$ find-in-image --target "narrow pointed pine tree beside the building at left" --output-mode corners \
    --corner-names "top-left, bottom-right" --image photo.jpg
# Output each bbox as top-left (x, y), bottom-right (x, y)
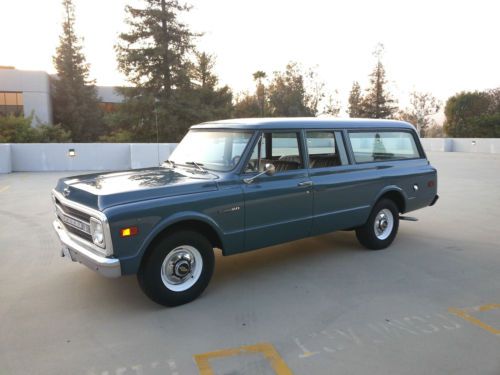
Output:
top-left (52, 0), bottom-right (104, 142)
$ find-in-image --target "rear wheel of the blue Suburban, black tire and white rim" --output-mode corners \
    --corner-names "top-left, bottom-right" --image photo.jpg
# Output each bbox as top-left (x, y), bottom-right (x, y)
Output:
top-left (356, 199), bottom-right (399, 250)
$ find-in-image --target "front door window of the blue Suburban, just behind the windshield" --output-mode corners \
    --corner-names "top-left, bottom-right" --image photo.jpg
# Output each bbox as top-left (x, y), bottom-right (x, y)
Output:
top-left (245, 132), bottom-right (304, 172)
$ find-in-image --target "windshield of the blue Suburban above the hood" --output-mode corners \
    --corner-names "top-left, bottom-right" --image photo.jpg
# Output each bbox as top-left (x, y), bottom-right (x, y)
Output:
top-left (169, 130), bottom-right (252, 172)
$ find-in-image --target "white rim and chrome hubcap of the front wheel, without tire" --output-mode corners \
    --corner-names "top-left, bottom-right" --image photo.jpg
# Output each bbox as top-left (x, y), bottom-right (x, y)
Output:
top-left (161, 245), bottom-right (203, 292)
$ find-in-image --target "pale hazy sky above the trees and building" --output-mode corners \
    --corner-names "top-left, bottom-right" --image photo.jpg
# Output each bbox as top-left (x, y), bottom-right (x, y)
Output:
top-left (0, 0), bottom-right (500, 114)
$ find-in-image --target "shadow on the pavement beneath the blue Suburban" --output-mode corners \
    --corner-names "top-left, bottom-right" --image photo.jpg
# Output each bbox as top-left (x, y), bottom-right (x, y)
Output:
top-left (57, 232), bottom-right (363, 314)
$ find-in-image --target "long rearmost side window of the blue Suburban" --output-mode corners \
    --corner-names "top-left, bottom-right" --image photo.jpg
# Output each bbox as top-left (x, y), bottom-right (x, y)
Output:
top-left (349, 131), bottom-right (420, 163)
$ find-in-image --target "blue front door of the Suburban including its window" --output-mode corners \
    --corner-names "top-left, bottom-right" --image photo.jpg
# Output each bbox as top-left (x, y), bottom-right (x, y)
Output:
top-left (242, 131), bottom-right (313, 250)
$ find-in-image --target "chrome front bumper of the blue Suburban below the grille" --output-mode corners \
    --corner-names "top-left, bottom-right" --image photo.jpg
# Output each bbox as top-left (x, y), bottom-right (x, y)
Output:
top-left (52, 220), bottom-right (122, 277)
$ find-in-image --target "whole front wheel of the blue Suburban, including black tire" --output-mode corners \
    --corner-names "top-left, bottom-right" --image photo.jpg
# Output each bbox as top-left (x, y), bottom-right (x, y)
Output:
top-left (137, 230), bottom-right (214, 306)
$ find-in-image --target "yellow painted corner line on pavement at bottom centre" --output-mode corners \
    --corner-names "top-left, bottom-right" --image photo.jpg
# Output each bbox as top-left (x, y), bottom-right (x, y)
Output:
top-left (193, 343), bottom-right (293, 375)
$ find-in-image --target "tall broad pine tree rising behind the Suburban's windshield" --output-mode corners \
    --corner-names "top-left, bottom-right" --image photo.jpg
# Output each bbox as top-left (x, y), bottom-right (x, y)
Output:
top-left (115, 0), bottom-right (199, 141)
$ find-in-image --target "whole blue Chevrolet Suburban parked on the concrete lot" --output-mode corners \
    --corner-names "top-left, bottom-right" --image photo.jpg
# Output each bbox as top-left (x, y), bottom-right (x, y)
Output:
top-left (52, 118), bottom-right (438, 306)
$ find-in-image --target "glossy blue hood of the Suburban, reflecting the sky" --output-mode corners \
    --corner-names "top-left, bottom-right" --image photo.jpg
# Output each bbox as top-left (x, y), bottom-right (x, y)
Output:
top-left (56, 168), bottom-right (217, 210)
